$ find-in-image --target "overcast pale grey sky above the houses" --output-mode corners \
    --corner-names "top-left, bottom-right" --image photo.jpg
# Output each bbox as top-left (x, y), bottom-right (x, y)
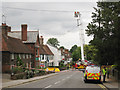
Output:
top-left (2, 0), bottom-right (97, 49)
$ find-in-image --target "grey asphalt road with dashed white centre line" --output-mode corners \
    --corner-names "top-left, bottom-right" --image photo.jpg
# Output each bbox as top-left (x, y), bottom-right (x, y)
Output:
top-left (10, 70), bottom-right (102, 90)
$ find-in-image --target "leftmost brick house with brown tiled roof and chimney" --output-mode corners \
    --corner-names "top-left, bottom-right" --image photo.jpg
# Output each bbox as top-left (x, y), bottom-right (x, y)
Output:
top-left (0, 24), bottom-right (33, 73)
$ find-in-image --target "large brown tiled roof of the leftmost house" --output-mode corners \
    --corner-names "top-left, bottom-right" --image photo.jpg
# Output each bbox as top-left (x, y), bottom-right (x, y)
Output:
top-left (2, 35), bottom-right (32, 53)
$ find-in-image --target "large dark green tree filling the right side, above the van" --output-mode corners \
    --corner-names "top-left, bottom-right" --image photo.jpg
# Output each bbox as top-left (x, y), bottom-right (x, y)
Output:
top-left (86, 2), bottom-right (120, 66)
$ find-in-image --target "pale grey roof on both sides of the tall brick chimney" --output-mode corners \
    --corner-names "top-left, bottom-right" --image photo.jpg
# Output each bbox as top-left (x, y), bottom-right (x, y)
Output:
top-left (8, 31), bottom-right (39, 43)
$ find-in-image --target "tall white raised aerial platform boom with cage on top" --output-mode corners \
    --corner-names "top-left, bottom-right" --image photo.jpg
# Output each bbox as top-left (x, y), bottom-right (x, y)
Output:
top-left (74, 12), bottom-right (84, 62)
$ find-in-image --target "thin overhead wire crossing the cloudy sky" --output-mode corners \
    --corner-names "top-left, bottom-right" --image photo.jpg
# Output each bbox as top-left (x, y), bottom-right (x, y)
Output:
top-left (3, 7), bottom-right (91, 12)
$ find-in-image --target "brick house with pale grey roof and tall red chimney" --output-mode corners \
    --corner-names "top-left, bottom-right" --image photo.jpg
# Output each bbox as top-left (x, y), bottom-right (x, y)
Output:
top-left (8, 24), bottom-right (40, 67)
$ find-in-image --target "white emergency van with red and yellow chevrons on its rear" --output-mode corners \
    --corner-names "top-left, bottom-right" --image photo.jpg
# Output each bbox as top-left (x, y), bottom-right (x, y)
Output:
top-left (84, 65), bottom-right (101, 83)
